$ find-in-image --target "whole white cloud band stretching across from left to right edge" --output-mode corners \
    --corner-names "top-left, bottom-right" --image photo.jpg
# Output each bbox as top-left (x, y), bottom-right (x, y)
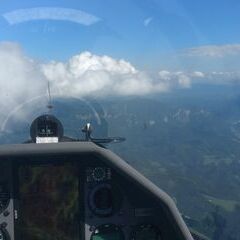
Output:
top-left (0, 42), bottom-right (240, 129)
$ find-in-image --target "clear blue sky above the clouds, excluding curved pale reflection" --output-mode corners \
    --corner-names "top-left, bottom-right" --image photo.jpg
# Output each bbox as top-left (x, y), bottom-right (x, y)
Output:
top-left (0, 0), bottom-right (240, 70)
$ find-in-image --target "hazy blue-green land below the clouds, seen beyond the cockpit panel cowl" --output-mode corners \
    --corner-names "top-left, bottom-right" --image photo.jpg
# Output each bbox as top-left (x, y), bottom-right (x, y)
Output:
top-left (0, 86), bottom-right (240, 240)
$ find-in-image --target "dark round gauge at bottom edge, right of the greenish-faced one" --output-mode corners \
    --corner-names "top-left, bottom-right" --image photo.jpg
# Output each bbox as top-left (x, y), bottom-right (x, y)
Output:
top-left (131, 224), bottom-right (162, 240)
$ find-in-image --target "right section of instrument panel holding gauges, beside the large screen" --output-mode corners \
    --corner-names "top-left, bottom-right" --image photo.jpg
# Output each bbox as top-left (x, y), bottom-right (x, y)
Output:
top-left (84, 165), bottom-right (163, 240)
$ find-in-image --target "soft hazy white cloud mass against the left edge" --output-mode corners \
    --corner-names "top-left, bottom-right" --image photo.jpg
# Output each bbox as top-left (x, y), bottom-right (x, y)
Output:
top-left (0, 42), bottom-right (45, 119)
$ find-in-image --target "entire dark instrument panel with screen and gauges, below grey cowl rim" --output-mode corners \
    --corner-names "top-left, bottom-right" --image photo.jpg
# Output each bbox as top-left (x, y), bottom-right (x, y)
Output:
top-left (0, 153), bottom-right (189, 240)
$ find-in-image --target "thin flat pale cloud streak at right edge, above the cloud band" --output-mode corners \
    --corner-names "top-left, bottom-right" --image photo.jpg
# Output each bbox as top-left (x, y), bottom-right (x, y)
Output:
top-left (182, 44), bottom-right (240, 58)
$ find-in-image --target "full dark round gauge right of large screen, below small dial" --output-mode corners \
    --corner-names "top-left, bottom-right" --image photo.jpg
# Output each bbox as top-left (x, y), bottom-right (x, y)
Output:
top-left (88, 183), bottom-right (122, 217)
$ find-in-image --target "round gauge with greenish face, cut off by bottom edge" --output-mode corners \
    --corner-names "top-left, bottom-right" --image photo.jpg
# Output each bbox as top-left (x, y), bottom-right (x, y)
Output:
top-left (91, 224), bottom-right (124, 240)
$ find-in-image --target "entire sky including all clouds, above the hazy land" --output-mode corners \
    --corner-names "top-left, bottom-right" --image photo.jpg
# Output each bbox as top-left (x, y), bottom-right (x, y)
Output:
top-left (0, 0), bottom-right (240, 125)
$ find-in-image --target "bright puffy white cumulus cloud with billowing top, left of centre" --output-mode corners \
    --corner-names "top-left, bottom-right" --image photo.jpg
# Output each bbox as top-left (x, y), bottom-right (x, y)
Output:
top-left (42, 52), bottom-right (177, 96)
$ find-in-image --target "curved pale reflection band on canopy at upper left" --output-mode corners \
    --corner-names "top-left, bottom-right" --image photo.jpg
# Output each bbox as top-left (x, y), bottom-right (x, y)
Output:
top-left (3, 7), bottom-right (100, 26)
